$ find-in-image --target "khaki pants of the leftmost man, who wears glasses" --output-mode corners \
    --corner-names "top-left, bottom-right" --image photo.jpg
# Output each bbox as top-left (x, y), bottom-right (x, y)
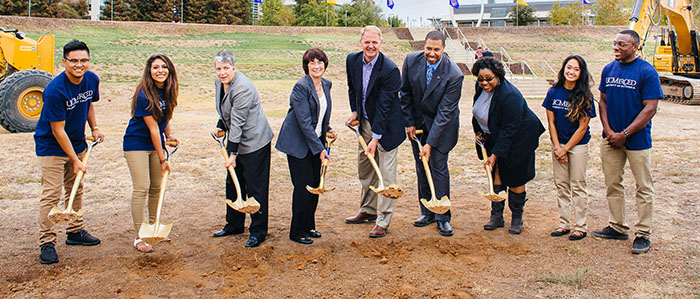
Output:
top-left (39, 152), bottom-right (85, 245)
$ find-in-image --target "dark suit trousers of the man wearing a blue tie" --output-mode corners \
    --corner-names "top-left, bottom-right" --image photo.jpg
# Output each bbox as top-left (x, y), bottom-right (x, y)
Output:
top-left (411, 135), bottom-right (452, 221)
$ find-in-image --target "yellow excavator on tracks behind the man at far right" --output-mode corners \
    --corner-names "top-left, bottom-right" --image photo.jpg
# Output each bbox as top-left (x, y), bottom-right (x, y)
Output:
top-left (629, 0), bottom-right (700, 105)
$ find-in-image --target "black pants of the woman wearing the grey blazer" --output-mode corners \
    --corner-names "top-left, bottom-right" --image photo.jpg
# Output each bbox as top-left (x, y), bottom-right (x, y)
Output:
top-left (224, 143), bottom-right (271, 241)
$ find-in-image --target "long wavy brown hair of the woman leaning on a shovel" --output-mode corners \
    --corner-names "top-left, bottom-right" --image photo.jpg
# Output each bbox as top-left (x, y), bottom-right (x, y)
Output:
top-left (131, 54), bottom-right (179, 122)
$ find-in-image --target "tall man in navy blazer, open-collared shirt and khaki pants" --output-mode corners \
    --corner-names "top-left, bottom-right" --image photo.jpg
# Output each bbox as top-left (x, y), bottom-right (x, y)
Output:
top-left (345, 26), bottom-right (406, 238)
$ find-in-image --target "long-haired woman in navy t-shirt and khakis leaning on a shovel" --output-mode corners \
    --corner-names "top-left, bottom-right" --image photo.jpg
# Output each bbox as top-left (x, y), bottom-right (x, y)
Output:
top-left (123, 54), bottom-right (178, 252)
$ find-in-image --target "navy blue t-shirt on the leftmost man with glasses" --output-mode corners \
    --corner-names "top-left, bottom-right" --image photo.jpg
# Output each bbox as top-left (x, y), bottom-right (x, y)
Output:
top-left (34, 71), bottom-right (100, 156)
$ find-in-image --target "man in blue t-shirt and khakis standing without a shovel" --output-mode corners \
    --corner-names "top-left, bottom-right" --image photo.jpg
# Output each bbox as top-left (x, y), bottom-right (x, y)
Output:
top-left (593, 30), bottom-right (664, 254)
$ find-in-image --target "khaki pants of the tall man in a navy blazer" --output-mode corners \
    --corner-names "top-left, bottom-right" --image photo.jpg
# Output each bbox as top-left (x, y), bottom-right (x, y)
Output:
top-left (357, 118), bottom-right (399, 228)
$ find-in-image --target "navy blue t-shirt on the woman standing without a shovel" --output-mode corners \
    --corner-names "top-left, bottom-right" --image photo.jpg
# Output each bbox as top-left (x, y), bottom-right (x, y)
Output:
top-left (542, 86), bottom-right (596, 145)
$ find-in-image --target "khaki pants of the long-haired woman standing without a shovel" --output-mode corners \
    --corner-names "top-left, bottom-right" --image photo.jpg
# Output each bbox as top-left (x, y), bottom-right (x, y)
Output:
top-left (552, 144), bottom-right (588, 232)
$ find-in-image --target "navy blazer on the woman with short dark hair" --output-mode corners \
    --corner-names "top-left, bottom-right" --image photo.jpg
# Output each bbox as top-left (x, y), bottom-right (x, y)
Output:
top-left (275, 75), bottom-right (333, 159)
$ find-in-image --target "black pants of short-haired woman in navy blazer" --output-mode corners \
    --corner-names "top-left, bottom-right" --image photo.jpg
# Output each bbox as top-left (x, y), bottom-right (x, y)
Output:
top-left (287, 151), bottom-right (321, 239)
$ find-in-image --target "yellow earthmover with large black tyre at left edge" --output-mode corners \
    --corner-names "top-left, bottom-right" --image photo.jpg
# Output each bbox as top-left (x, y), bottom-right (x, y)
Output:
top-left (0, 27), bottom-right (54, 133)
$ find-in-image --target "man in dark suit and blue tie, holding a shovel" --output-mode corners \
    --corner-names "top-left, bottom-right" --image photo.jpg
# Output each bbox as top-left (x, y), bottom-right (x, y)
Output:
top-left (401, 31), bottom-right (464, 236)
